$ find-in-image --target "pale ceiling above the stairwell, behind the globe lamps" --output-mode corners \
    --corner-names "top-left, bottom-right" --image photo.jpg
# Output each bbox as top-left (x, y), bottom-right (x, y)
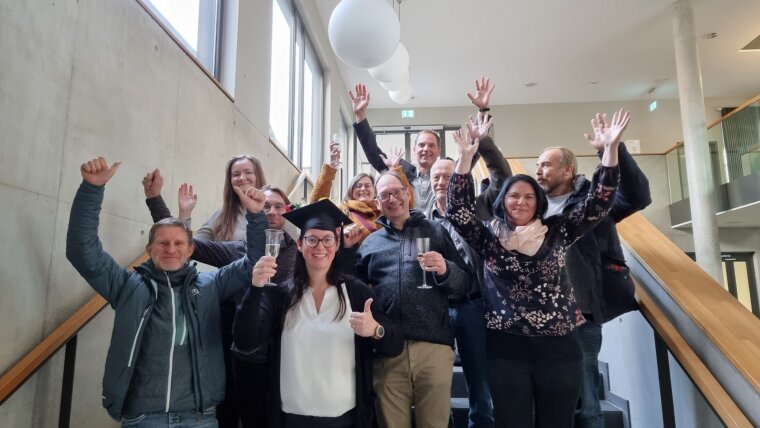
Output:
top-left (316, 0), bottom-right (760, 108)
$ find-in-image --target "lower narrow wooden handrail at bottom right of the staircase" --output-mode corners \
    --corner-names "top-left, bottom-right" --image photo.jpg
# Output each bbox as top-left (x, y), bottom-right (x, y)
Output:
top-left (636, 283), bottom-right (752, 427)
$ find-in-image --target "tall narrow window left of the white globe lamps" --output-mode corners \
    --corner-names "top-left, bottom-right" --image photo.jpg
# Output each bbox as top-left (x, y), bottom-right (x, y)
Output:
top-left (269, 0), bottom-right (323, 178)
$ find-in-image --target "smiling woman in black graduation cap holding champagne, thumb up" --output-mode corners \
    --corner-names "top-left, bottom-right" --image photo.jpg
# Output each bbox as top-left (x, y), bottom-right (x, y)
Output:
top-left (233, 200), bottom-right (404, 428)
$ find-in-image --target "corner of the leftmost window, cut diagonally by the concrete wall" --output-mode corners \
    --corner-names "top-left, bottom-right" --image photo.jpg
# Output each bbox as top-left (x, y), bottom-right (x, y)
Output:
top-left (143, 0), bottom-right (222, 79)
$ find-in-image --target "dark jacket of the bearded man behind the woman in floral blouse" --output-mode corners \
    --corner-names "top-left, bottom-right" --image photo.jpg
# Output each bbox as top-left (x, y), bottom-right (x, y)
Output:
top-left (562, 144), bottom-right (652, 324)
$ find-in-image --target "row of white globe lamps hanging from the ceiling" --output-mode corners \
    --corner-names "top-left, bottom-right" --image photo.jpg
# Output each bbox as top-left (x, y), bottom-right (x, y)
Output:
top-left (327, 0), bottom-right (412, 104)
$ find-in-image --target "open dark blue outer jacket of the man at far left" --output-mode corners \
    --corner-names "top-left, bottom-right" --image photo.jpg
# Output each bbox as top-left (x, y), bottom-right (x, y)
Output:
top-left (66, 182), bottom-right (267, 420)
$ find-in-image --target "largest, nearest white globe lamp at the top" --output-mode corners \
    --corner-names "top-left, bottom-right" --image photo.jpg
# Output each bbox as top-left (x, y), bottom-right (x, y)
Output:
top-left (327, 0), bottom-right (401, 68)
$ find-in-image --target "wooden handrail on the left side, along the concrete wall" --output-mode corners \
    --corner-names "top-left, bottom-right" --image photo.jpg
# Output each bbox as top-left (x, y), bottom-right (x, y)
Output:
top-left (0, 253), bottom-right (148, 404)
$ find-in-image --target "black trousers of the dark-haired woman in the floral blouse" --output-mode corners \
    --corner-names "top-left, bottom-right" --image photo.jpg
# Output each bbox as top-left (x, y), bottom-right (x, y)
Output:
top-left (487, 330), bottom-right (583, 428)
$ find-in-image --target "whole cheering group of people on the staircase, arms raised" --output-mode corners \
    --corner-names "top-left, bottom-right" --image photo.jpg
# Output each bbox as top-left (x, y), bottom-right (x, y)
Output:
top-left (66, 78), bottom-right (651, 428)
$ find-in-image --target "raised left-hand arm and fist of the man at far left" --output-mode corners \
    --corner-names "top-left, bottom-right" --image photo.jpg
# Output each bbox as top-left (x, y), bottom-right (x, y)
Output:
top-left (66, 157), bottom-right (128, 306)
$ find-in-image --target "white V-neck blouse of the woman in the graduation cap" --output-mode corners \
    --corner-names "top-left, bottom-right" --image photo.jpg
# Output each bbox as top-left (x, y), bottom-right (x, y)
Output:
top-left (280, 284), bottom-right (356, 417)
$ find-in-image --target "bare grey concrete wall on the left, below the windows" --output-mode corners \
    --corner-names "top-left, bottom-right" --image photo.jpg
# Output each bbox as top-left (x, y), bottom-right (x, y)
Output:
top-left (0, 0), bottom-right (348, 427)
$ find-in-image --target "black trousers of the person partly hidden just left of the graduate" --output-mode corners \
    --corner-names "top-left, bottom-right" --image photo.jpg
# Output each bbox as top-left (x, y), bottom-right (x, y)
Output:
top-left (232, 358), bottom-right (271, 428)
